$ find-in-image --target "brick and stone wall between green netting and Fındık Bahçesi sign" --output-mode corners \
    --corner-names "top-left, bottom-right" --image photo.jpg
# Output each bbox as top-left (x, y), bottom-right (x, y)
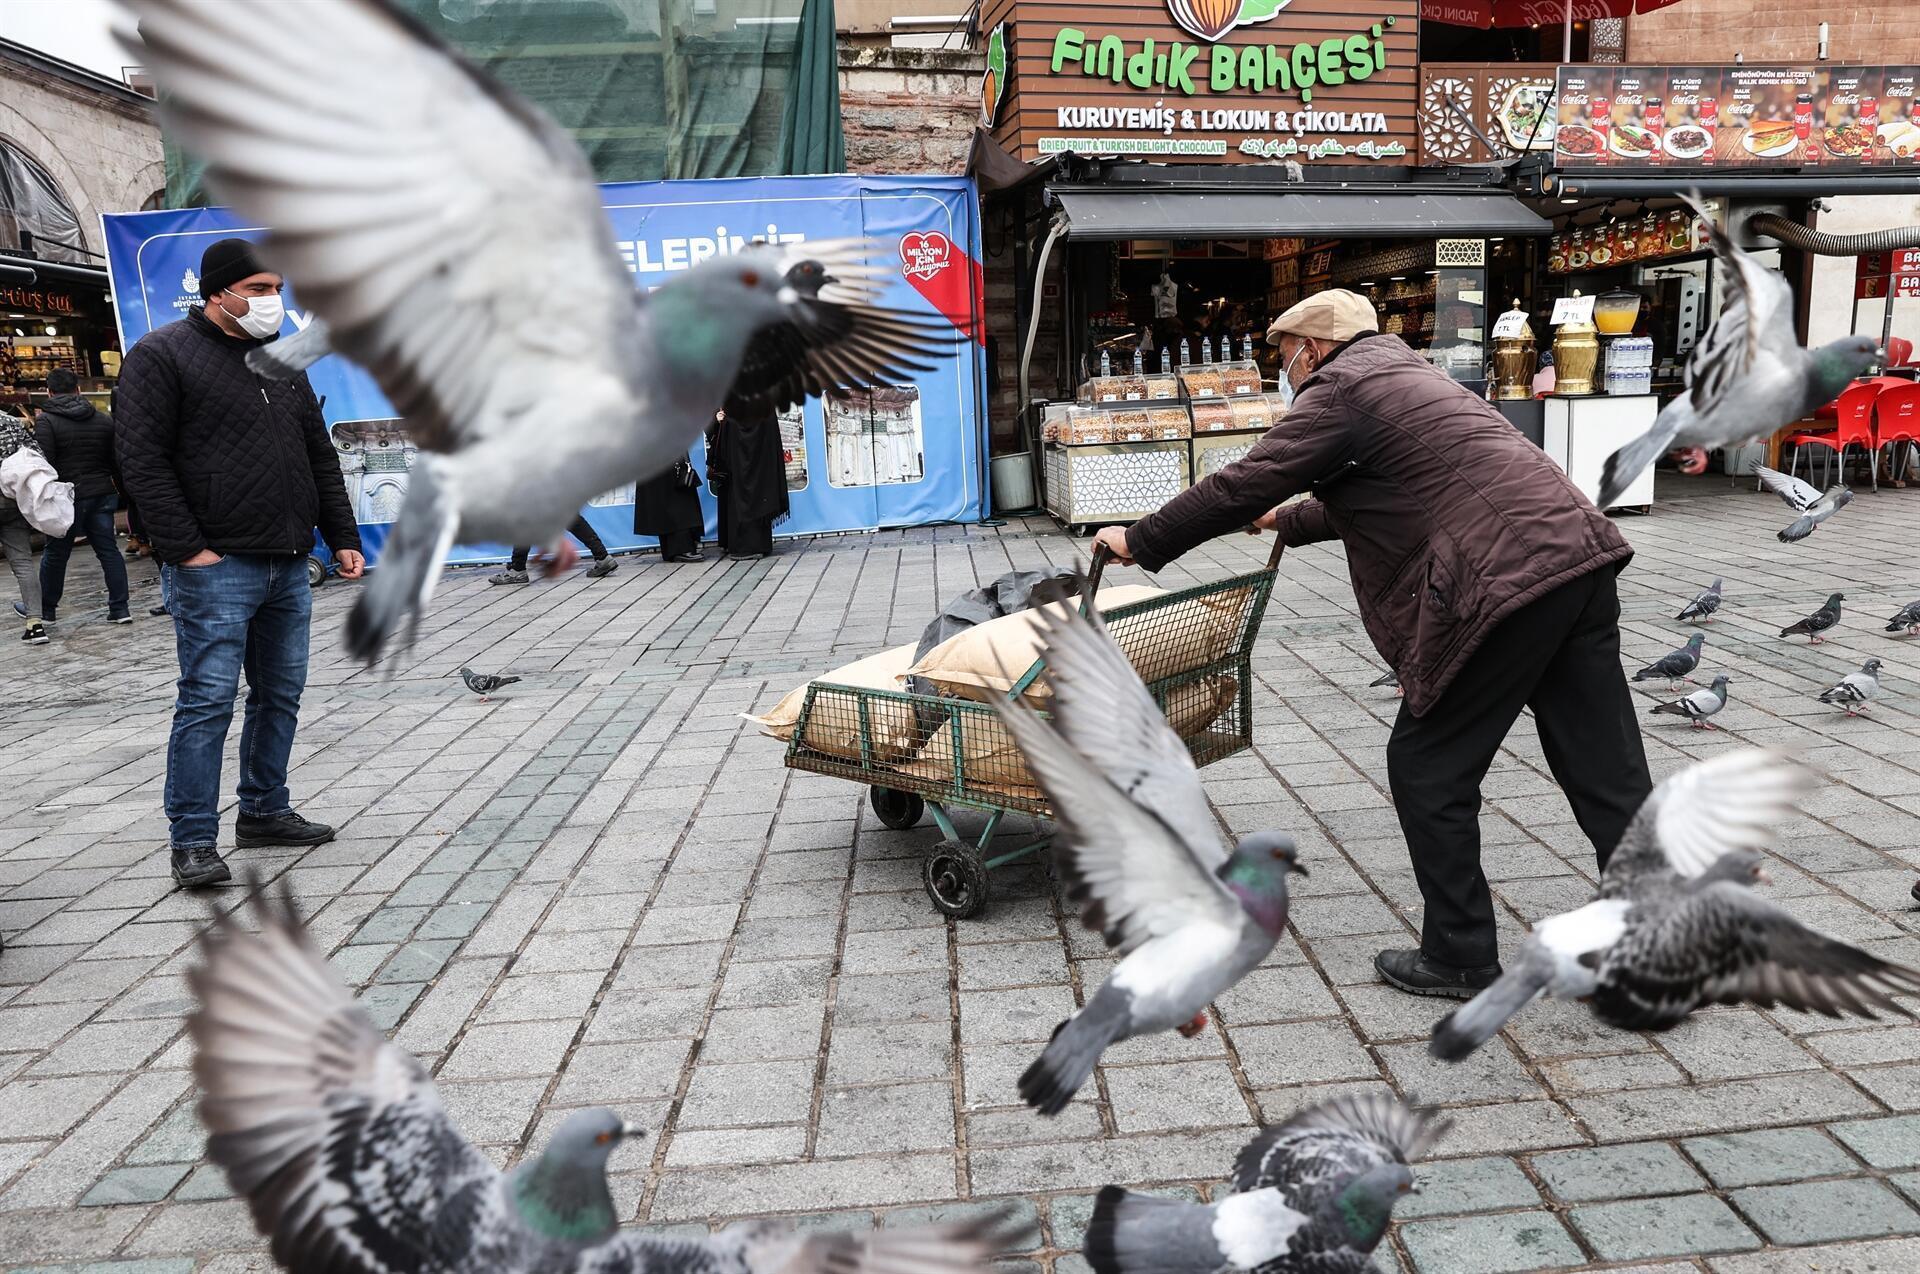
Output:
top-left (839, 44), bottom-right (985, 175)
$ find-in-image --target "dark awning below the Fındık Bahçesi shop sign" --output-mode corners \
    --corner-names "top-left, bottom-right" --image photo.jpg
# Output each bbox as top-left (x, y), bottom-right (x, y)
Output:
top-left (1048, 186), bottom-right (1553, 240)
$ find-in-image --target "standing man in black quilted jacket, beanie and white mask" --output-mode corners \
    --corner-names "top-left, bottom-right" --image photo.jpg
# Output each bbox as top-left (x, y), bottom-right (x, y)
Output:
top-left (115, 238), bottom-right (365, 888)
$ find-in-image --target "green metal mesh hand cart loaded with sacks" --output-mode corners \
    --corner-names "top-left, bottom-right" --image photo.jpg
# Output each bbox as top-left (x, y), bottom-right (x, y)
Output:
top-left (785, 543), bottom-right (1283, 919)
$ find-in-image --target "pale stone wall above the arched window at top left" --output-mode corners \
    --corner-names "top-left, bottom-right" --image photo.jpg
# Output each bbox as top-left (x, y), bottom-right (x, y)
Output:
top-left (0, 50), bottom-right (167, 251)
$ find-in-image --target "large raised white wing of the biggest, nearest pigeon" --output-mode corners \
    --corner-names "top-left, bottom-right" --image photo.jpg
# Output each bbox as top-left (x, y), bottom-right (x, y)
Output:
top-left (127, 0), bottom-right (639, 451)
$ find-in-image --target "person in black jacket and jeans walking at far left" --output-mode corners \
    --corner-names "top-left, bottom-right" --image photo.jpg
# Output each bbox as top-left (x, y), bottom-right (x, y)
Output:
top-left (33, 368), bottom-right (132, 624)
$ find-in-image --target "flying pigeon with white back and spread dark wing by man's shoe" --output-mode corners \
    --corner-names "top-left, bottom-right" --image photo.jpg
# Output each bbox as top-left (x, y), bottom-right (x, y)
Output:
top-left (1430, 748), bottom-right (1920, 1061)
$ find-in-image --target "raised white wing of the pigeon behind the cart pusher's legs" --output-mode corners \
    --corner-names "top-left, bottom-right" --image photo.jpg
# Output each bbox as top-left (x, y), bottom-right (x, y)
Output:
top-left (1601, 748), bottom-right (1811, 892)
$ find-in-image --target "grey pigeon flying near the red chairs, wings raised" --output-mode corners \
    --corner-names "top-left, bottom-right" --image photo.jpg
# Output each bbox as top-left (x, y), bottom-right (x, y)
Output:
top-left (1596, 196), bottom-right (1880, 508)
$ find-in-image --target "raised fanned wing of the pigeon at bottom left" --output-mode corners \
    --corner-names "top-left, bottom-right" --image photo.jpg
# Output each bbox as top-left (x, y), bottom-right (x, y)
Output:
top-left (186, 882), bottom-right (495, 1274)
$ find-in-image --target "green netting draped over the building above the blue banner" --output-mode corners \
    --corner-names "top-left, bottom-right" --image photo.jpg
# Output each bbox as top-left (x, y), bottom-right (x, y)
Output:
top-left (167, 0), bottom-right (817, 207)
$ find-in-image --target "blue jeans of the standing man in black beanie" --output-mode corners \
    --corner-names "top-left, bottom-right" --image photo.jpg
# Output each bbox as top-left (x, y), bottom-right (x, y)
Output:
top-left (163, 553), bottom-right (313, 848)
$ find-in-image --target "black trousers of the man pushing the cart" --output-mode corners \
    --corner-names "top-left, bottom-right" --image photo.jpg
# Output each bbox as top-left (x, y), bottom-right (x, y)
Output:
top-left (1386, 568), bottom-right (1653, 967)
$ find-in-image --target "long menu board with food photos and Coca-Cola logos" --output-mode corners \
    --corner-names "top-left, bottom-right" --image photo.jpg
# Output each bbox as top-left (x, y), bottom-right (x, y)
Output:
top-left (1553, 65), bottom-right (1920, 169)
